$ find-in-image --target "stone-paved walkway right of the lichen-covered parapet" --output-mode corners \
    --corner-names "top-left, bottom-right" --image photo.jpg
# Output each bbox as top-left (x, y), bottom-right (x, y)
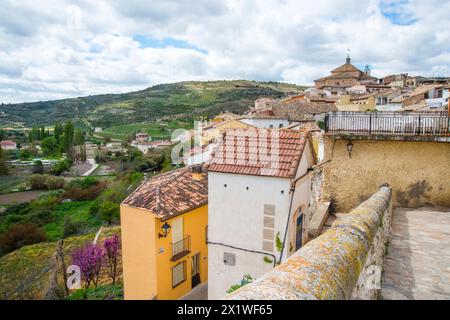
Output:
top-left (381, 208), bottom-right (450, 300)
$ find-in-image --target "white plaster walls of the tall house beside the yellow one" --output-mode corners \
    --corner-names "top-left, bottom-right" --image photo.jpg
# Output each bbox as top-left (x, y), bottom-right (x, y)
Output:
top-left (208, 144), bottom-right (312, 299)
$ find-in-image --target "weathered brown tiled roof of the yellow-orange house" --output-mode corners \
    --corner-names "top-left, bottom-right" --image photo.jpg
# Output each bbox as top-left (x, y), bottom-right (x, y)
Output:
top-left (122, 166), bottom-right (208, 219)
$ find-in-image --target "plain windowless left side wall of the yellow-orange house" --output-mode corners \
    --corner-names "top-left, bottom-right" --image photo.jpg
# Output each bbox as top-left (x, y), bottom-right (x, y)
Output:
top-left (120, 205), bottom-right (157, 300)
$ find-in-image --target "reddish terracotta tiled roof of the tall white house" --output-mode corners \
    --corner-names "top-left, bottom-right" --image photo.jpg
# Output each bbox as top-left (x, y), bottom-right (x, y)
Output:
top-left (208, 129), bottom-right (309, 178)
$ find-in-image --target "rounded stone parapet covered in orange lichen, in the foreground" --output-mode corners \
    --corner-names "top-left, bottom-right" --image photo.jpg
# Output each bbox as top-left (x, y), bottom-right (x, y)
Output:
top-left (226, 186), bottom-right (392, 300)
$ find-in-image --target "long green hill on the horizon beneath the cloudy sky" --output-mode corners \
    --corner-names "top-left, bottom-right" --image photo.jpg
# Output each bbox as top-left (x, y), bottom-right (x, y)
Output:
top-left (0, 80), bottom-right (305, 127)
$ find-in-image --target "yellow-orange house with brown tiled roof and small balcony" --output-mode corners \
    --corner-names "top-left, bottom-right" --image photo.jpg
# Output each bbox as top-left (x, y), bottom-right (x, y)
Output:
top-left (120, 166), bottom-right (208, 300)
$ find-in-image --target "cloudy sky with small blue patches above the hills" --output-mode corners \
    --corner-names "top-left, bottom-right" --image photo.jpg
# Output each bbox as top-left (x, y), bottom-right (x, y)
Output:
top-left (0, 0), bottom-right (450, 102)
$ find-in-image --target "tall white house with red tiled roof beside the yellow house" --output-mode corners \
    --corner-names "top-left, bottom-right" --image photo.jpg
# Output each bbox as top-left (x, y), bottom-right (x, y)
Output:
top-left (208, 129), bottom-right (316, 299)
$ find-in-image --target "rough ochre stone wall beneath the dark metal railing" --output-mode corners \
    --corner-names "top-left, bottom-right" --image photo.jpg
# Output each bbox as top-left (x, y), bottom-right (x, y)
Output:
top-left (322, 136), bottom-right (450, 212)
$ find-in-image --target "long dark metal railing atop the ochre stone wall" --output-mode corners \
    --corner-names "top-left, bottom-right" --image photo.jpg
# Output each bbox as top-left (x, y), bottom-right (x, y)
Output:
top-left (325, 111), bottom-right (450, 136)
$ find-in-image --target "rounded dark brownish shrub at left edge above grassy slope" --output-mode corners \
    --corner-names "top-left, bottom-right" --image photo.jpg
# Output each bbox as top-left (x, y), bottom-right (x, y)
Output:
top-left (0, 224), bottom-right (46, 254)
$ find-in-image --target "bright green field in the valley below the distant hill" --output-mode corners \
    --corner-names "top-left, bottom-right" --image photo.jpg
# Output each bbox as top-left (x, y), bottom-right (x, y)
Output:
top-left (96, 120), bottom-right (194, 140)
